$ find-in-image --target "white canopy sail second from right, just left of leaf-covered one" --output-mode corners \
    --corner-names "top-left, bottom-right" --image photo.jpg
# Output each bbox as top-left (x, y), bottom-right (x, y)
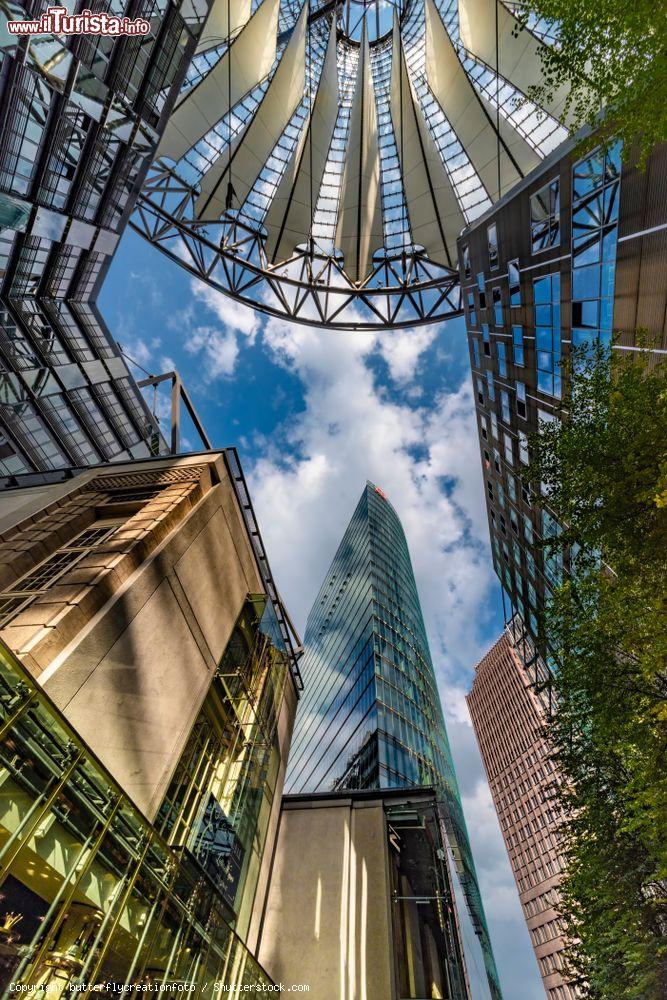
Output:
top-left (426, 0), bottom-right (540, 200)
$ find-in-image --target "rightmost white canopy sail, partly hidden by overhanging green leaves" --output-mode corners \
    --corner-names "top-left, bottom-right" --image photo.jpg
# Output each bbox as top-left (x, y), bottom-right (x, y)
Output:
top-left (459, 0), bottom-right (568, 125)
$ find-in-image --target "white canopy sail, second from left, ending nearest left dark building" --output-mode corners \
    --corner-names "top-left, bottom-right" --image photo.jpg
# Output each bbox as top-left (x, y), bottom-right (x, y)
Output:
top-left (157, 0), bottom-right (280, 160)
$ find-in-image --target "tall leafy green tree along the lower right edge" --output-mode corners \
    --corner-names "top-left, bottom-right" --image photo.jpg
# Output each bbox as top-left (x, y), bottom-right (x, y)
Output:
top-left (529, 342), bottom-right (667, 1000)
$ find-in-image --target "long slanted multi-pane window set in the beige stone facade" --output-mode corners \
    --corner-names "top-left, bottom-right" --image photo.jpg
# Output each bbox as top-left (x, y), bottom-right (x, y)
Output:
top-left (0, 521), bottom-right (123, 628)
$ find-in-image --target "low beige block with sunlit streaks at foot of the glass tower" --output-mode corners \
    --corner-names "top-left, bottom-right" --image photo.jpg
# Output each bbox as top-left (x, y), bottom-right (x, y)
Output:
top-left (259, 788), bottom-right (469, 1000)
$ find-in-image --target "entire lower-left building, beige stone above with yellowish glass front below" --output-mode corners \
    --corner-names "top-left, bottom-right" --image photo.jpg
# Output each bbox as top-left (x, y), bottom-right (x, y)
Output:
top-left (0, 450), bottom-right (300, 1000)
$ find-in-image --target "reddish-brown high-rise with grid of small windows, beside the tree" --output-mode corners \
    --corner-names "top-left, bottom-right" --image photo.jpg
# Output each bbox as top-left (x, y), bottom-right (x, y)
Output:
top-left (467, 631), bottom-right (580, 1000)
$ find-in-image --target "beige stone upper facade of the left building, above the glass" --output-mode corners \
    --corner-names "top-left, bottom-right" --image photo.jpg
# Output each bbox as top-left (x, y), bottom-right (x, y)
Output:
top-left (0, 453), bottom-right (294, 819)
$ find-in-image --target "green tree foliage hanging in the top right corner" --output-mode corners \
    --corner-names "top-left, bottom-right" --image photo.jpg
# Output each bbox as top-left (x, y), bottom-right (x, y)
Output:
top-left (517, 0), bottom-right (667, 163)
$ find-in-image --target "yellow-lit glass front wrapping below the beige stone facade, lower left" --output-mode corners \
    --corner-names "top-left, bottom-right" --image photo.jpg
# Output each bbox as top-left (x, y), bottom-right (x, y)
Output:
top-left (0, 598), bottom-right (288, 997)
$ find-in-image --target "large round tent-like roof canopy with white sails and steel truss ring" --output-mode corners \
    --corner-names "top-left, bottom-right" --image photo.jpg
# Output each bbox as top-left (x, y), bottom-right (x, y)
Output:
top-left (133, 0), bottom-right (567, 328)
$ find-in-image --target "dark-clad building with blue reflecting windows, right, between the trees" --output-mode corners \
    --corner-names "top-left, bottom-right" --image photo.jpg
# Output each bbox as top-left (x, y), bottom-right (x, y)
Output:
top-left (459, 133), bottom-right (667, 664)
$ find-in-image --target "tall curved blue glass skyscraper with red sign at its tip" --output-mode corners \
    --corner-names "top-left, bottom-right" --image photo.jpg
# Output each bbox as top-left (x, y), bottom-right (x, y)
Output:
top-left (286, 483), bottom-right (500, 997)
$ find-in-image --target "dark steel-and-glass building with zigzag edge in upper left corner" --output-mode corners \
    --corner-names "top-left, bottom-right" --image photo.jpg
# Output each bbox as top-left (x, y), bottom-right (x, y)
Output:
top-left (0, 0), bottom-right (213, 483)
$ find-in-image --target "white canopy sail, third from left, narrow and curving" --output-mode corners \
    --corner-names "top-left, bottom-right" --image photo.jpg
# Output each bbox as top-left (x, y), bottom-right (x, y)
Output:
top-left (195, 3), bottom-right (308, 219)
